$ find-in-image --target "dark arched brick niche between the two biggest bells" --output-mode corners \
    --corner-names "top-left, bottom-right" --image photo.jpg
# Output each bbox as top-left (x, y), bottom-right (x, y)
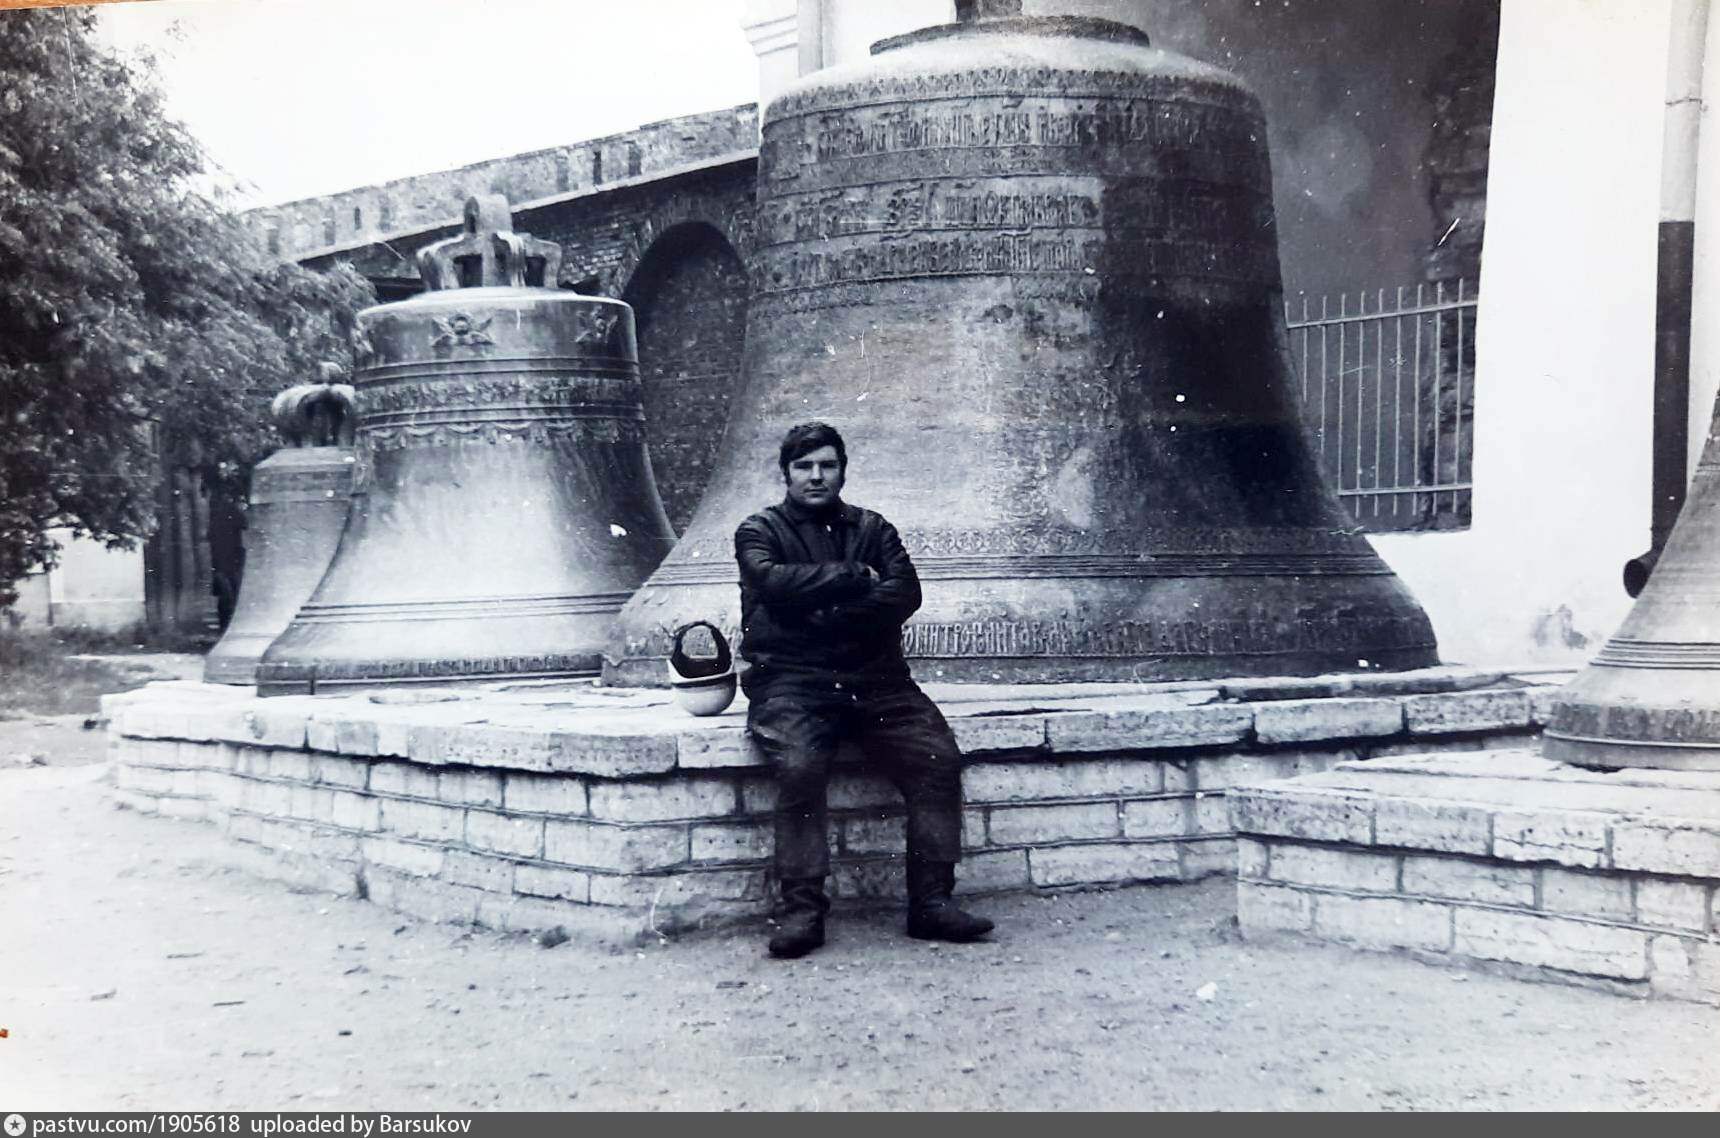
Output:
top-left (621, 220), bottom-right (746, 533)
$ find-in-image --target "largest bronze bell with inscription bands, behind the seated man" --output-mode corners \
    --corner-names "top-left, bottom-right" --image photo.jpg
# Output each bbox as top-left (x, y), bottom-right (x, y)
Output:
top-left (605, 17), bottom-right (1436, 682)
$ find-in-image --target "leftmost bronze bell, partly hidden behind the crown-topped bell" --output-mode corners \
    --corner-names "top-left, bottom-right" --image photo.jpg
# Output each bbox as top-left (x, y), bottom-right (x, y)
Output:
top-left (203, 374), bottom-right (356, 684)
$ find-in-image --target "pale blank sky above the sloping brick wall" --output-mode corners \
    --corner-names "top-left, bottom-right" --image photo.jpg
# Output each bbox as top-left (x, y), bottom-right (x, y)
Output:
top-left (100, 0), bottom-right (759, 206)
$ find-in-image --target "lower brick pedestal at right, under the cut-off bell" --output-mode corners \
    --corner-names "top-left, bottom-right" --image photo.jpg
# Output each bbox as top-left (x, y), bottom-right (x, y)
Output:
top-left (1230, 749), bottom-right (1720, 1002)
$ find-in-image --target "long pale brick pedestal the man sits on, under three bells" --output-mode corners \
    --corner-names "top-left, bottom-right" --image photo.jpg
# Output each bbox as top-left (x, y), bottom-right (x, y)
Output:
top-left (105, 669), bottom-right (1567, 935)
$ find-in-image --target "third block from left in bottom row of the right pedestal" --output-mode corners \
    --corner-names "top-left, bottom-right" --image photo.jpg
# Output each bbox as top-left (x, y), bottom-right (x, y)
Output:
top-left (1455, 908), bottom-right (1648, 980)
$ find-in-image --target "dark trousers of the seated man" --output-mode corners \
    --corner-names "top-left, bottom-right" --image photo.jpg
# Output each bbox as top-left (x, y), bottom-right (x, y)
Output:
top-left (746, 679), bottom-right (961, 882)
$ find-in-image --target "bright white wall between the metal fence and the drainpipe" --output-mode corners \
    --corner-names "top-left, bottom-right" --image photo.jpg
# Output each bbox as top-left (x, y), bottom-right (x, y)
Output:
top-left (1374, 0), bottom-right (1664, 664)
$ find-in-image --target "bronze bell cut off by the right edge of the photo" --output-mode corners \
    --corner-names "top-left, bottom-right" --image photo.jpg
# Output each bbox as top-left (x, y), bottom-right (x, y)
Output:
top-left (1541, 388), bottom-right (1720, 770)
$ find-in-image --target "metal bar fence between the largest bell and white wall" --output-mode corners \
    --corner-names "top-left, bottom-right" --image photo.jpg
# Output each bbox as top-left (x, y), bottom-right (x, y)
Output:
top-left (1285, 280), bottom-right (1477, 531)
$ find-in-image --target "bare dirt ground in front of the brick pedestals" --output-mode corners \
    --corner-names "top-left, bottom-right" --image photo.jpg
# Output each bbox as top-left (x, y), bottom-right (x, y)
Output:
top-left (0, 717), bottom-right (1720, 1110)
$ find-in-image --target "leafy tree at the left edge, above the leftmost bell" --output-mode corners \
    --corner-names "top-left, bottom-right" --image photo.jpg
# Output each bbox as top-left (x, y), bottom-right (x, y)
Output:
top-left (0, 9), bottom-right (375, 607)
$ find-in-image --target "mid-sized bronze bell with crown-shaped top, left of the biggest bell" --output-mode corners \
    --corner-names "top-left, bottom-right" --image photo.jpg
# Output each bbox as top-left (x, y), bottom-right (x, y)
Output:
top-left (258, 196), bottom-right (674, 694)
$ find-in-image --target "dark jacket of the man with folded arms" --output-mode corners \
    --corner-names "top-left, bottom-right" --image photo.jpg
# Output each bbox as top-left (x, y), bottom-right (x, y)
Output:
top-left (734, 500), bottom-right (920, 696)
